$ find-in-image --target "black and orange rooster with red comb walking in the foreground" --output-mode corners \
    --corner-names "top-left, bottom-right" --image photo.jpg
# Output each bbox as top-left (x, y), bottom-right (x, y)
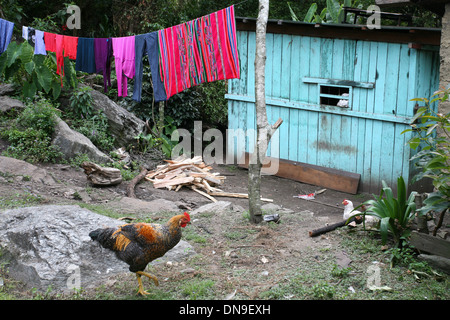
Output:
top-left (89, 212), bottom-right (191, 295)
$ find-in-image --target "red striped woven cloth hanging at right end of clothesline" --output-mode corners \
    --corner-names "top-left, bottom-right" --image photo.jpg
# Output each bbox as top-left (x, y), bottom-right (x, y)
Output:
top-left (159, 6), bottom-right (240, 98)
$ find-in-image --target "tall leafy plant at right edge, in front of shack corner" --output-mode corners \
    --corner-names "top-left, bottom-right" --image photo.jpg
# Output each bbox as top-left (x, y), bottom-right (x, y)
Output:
top-left (402, 89), bottom-right (450, 218)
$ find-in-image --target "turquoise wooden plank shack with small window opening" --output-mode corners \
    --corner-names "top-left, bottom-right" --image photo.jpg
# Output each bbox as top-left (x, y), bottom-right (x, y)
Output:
top-left (226, 18), bottom-right (440, 193)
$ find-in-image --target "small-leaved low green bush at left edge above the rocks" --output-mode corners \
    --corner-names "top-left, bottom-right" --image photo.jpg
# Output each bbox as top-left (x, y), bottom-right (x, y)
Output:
top-left (0, 97), bottom-right (61, 163)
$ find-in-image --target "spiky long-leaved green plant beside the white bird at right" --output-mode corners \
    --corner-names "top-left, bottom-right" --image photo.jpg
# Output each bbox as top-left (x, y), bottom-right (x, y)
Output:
top-left (355, 177), bottom-right (416, 247)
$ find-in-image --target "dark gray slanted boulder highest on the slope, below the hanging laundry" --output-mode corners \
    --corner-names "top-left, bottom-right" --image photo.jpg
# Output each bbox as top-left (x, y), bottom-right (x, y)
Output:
top-left (91, 90), bottom-right (145, 147)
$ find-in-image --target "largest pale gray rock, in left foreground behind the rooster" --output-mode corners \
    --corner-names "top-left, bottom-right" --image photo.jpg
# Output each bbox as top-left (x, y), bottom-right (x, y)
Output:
top-left (0, 205), bottom-right (194, 291)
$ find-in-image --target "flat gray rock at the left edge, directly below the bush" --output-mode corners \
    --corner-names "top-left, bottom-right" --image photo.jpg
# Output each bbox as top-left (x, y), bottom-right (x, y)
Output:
top-left (0, 156), bottom-right (56, 185)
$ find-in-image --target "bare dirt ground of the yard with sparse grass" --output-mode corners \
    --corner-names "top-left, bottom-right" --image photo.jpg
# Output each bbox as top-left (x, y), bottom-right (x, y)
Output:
top-left (0, 148), bottom-right (448, 299)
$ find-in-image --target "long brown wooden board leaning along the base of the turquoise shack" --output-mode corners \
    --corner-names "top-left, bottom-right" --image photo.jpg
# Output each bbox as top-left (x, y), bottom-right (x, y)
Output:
top-left (239, 152), bottom-right (361, 194)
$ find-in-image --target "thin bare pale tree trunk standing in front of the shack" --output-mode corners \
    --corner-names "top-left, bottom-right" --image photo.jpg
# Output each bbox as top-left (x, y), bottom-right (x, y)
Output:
top-left (248, 0), bottom-right (282, 223)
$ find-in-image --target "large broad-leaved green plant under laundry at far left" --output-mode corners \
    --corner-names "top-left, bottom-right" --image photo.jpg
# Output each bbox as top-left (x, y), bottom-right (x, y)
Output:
top-left (0, 41), bottom-right (77, 99)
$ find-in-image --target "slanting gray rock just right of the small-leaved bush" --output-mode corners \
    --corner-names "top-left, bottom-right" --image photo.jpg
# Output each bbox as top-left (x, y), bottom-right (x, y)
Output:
top-left (52, 118), bottom-right (112, 163)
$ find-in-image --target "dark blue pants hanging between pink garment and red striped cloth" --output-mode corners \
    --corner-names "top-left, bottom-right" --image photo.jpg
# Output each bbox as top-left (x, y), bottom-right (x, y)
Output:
top-left (133, 31), bottom-right (167, 102)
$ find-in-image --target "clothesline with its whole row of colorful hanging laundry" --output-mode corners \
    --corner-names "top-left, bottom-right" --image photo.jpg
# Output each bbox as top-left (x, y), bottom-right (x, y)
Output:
top-left (0, 5), bottom-right (241, 102)
